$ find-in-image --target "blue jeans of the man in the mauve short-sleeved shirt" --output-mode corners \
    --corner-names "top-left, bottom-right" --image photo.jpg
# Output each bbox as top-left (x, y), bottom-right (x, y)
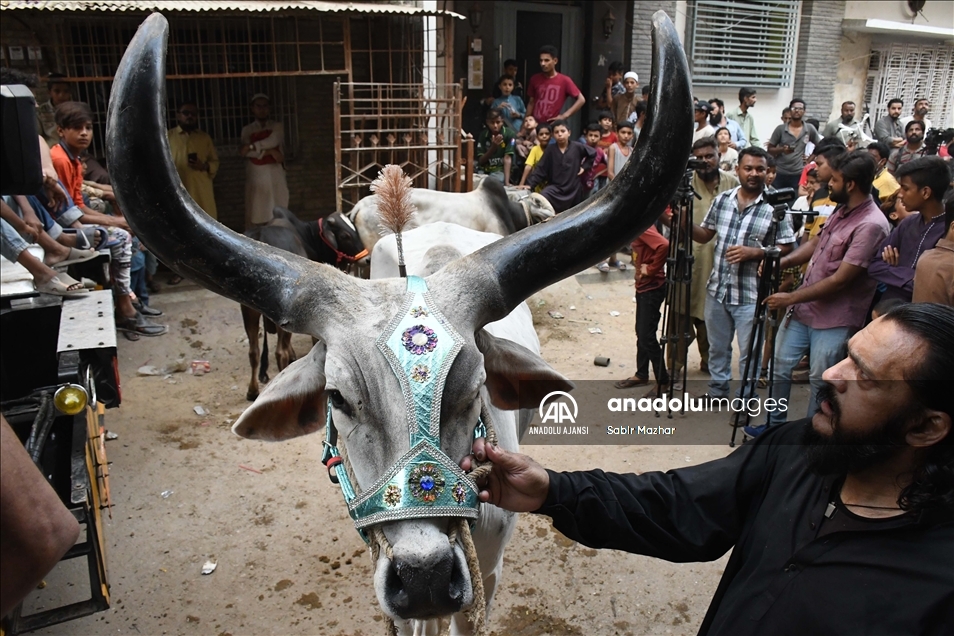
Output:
top-left (769, 318), bottom-right (856, 426)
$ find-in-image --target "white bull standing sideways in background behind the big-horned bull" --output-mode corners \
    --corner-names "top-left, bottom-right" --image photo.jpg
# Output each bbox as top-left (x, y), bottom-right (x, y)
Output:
top-left (349, 179), bottom-right (554, 254)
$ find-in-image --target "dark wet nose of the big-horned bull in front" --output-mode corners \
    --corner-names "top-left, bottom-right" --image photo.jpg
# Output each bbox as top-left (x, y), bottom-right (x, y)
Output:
top-left (385, 545), bottom-right (468, 619)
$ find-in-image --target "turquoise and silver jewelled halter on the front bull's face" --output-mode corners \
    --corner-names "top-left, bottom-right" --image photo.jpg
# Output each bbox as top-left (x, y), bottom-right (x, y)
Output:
top-left (321, 276), bottom-right (487, 543)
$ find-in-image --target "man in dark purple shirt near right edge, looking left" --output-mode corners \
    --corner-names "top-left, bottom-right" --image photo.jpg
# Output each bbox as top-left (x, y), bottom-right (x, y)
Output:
top-left (868, 157), bottom-right (951, 302)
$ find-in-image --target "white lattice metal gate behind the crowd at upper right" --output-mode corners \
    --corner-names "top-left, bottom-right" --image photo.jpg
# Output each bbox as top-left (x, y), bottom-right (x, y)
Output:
top-left (865, 44), bottom-right (954, 128)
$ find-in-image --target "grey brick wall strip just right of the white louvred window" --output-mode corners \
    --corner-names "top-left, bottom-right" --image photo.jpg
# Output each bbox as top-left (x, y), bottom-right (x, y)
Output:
top-left (793, 0), bottom-right (845, 126)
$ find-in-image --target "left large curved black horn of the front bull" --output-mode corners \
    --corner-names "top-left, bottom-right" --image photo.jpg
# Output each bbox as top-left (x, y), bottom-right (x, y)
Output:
top-left (106, 13), bottom-right (336, 331)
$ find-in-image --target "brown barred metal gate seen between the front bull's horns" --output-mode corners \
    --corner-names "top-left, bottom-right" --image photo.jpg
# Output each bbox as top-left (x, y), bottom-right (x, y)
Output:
top-left (334, 82), bottom-right (472, 212)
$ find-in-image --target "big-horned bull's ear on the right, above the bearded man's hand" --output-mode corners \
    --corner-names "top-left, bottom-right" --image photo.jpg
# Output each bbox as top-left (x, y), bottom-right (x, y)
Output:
top-left (474, 329), bottom-right (573, 411)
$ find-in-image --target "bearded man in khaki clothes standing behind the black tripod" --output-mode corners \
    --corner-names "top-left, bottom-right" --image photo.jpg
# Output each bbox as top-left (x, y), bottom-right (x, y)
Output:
top-left (669, 137), bottom-right (739, 376)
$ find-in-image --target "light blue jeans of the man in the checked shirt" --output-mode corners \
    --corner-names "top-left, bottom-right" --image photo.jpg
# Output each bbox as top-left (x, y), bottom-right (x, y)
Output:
top-left (705, 294), bottom-right (758, 397)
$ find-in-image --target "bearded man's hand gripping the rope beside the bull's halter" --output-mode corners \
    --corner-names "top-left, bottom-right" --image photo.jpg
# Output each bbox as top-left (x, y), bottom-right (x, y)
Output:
top-left (460, 439), bottom-right (550, 512)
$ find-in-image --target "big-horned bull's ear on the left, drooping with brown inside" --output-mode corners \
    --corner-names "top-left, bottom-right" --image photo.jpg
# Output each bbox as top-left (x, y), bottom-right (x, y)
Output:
top-left (232, 342), bottom-right (327, 442)
